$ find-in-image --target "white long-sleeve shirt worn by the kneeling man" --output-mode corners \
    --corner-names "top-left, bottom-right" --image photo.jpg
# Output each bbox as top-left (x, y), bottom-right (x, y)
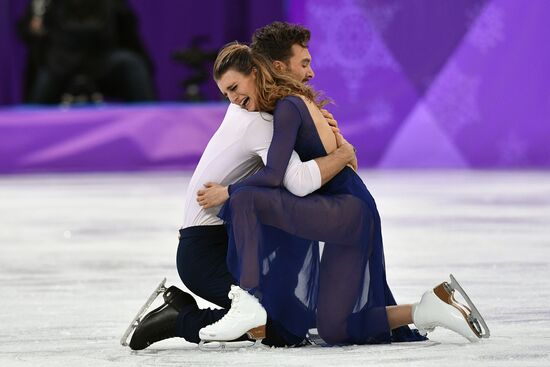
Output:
top-left (182, 104), bottom-right (321, 228)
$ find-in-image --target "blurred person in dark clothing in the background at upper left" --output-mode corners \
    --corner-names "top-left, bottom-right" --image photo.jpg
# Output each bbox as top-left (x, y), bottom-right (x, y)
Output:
top-left (19, 0), bottom-right (155, 104)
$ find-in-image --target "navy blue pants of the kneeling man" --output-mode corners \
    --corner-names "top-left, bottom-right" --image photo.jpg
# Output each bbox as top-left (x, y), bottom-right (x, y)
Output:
top-left (176, 225), bottom-right (302, 346)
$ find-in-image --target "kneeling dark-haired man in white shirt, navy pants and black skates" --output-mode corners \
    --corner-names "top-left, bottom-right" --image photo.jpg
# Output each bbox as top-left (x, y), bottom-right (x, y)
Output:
top-left (125, 22), bottom-right (355, 350)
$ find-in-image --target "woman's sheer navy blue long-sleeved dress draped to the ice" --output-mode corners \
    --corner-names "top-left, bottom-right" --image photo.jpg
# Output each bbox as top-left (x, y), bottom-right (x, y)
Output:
top-left (219, 96), bottom-right (425, 345)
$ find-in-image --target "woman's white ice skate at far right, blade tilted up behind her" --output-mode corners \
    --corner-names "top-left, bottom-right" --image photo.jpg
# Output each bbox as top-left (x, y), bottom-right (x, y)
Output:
top-left (413, 274), bottom-right (490, 342)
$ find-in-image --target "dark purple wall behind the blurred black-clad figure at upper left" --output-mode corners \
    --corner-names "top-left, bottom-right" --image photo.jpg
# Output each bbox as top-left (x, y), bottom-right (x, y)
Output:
top-left (0, 0), bottom-right (285, 105)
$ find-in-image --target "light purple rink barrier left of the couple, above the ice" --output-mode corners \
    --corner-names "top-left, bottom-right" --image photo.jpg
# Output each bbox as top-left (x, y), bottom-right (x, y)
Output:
top-left (0, 104), bottom-right (227, 173)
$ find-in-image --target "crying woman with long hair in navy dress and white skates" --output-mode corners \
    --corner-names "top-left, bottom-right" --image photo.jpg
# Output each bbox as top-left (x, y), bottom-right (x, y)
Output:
top-left (197, 43), bottom-right (490, 345)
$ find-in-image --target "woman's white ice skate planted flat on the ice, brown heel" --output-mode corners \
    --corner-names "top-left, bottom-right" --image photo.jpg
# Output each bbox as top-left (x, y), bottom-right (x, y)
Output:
top-left (199, 285), bottom-right (267, 350)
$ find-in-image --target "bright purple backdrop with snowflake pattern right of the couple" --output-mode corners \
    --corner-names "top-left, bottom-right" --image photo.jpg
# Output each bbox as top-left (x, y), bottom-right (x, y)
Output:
top-left (289, 0), bottom-right (550, 167)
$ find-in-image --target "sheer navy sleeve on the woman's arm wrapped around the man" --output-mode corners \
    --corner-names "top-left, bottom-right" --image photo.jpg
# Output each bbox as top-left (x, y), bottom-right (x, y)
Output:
top-left (228, 98), bottom-right (302, 195)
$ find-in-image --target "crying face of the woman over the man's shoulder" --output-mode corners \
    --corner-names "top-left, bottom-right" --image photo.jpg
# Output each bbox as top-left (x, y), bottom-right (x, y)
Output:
top-left (217, 69), bottom-right (258, 111)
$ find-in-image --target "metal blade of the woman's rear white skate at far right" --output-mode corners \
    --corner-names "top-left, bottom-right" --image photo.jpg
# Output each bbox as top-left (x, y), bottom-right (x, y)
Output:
top-left (439, 274), bottom-right (491, 338)
